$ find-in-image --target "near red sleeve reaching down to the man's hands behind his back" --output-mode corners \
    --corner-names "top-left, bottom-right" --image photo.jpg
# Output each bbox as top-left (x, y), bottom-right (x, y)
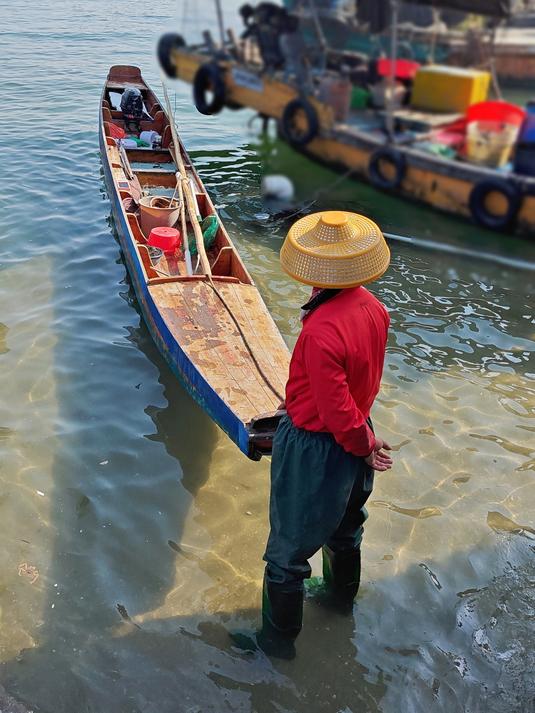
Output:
top-left (303, 335), bottom-right (375, 456)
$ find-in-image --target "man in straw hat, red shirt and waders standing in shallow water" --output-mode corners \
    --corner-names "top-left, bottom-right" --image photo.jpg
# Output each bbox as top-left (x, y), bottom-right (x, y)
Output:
top-left (259, 211), bottom-right (392, 650)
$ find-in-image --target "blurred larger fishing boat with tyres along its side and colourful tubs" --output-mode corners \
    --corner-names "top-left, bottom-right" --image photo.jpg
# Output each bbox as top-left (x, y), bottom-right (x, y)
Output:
top-left (158, 0), bottom-right (535, 236)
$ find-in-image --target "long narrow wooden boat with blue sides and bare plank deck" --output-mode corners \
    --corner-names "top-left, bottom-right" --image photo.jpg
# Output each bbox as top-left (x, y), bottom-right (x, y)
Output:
top-left (100, 66), bottom-right (289, 459)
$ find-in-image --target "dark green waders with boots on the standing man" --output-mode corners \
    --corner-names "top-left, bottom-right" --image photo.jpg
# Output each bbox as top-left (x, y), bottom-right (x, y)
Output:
top-left (262, 416), bottom-right (373, 640)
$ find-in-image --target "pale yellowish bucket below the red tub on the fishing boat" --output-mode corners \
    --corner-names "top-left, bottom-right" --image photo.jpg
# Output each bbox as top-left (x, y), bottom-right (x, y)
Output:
top-left (466, 121), bottom-right (519, 168)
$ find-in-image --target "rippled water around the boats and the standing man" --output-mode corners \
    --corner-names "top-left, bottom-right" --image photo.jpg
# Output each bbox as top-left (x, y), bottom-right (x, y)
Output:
top-left (0, 0), bottom-right (535, 713)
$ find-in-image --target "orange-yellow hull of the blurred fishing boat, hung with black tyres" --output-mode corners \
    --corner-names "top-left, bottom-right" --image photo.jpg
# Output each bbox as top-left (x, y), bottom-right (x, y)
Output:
top-left (159, 33), bottom-right (535, 237)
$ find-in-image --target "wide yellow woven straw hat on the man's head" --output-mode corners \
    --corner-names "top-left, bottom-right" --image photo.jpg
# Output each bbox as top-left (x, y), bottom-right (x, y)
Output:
top-left (280, 210), bottom-right (390, 289)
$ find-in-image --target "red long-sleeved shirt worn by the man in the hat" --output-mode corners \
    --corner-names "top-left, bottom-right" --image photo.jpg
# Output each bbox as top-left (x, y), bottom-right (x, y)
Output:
top-left (286, 287), bottom-right (390, 456)
